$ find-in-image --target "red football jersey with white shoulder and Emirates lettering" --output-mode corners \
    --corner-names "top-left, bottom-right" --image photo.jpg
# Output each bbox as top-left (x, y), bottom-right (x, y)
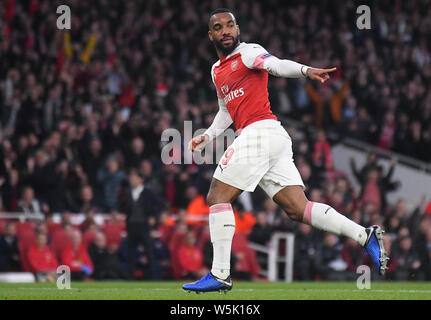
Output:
top-left (211, 42), bottom-right (277, 130)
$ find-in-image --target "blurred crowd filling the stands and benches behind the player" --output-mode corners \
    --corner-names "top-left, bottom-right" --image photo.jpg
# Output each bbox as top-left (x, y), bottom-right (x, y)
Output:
top-left (0, 0), bottom-right (431, 280)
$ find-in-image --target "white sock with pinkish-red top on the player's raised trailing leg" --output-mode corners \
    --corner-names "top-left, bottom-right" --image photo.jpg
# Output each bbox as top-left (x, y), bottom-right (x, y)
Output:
top-left (302, 201), bottom-right (367, 246)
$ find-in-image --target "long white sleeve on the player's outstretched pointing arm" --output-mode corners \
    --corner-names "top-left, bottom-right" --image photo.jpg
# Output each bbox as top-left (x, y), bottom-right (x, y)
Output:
top-left (242, 44), bottom-right (309, 78)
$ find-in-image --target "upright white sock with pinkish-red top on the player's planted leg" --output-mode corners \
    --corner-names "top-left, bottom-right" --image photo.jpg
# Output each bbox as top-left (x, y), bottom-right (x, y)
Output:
top-left (209, 203), bottom-right (235, 280)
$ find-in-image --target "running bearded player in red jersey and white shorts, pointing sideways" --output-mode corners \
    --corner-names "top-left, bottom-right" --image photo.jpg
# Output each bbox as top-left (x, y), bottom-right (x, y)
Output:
top-left (183, 9), bottom-right (389, 293)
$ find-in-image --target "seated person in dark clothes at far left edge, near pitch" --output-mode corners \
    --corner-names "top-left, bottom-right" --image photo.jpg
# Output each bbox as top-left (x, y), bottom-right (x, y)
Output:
top-left (0, 222), bottom-right (21, 272)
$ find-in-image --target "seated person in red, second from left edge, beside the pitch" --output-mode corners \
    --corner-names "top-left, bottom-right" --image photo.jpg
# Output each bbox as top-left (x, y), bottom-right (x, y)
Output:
top-left (27, 232), bottom-right (58, 283)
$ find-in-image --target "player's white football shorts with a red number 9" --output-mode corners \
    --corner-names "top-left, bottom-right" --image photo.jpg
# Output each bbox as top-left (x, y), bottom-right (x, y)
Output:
top-left (214, 119), bottom-right (304, 199)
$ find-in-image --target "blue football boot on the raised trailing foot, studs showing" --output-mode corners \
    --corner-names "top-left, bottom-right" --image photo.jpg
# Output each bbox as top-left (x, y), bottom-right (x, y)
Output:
top-left (364, 226), bottom-right (389, 276)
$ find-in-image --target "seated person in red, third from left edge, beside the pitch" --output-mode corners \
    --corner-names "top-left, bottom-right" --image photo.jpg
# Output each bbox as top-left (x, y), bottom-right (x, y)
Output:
top-left (61, 229), bottom-right (94, 280)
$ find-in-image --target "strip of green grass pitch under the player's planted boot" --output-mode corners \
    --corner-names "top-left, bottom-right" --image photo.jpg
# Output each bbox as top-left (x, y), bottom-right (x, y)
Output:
top-left (0, 281), bottom-right (431, 300)
